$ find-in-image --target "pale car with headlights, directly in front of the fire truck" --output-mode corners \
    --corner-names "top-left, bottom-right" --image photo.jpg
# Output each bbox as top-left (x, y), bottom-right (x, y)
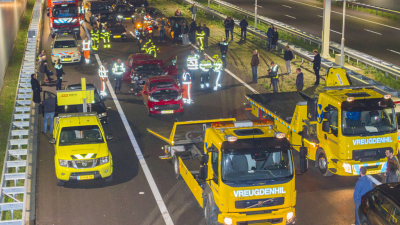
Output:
top-left (51, 35), bottom-right (81, 63)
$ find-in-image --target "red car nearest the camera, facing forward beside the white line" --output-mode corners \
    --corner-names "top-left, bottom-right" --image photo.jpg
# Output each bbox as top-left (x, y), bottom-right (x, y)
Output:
top-left (142, 75), bottom-right (183, 115)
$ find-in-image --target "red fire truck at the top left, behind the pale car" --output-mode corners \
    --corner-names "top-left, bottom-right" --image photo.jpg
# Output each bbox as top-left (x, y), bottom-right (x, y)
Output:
top-left (47, 0), bottom-right (83, 38)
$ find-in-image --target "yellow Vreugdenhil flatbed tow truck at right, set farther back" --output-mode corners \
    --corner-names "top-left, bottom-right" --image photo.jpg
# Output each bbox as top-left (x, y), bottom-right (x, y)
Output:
top-left (246, 68), bottom-right (398, 176)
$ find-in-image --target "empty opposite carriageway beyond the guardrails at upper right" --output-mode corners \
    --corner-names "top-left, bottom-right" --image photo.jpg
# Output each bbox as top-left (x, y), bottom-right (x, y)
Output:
top-left (226, 0), bottom-right (400, 66)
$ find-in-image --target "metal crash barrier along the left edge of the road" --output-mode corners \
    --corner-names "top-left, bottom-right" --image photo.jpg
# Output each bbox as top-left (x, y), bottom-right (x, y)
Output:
top-left (0, 0), bottom-right (42, 225)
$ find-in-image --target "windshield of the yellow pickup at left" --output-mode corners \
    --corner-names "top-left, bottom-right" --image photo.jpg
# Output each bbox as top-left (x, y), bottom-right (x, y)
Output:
top-left (58, 125), bottom-right (104, 146)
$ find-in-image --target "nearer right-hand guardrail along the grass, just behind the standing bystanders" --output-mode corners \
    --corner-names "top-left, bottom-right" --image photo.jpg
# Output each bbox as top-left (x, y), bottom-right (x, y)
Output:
top-left (183, 0), bottom-right (400, 97)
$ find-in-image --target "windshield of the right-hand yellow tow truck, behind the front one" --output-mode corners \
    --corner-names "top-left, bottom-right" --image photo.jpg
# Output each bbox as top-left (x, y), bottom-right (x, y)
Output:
top-left (342, 108), bottom-right (397, 136)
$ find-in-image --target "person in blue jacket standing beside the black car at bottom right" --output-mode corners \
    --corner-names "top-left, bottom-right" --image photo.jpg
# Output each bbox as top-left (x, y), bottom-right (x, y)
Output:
top-left (353, 166), bottom-right (373, 225)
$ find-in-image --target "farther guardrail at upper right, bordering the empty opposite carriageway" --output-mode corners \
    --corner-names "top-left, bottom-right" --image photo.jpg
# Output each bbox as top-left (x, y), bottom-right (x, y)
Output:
top-left (205, 0), bottom-right (400, 80)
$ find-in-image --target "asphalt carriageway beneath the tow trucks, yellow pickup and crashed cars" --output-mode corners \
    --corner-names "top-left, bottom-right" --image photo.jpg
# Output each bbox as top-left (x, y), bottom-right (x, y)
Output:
top-left (36, 3), bottom-right (378, 225)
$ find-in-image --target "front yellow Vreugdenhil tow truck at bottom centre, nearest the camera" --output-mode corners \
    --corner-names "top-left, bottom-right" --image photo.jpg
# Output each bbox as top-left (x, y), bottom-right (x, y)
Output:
top-left (148, 118), bottom-right (306, 225)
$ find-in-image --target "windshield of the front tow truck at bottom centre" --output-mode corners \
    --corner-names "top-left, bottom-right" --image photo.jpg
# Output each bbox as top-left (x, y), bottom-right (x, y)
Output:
top-left (221, 150), bottom-right (293, 182)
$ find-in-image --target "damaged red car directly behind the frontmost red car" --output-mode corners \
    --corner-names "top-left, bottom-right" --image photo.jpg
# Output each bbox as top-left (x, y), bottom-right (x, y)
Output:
top-left (122, 53), bottom-right (178, 83)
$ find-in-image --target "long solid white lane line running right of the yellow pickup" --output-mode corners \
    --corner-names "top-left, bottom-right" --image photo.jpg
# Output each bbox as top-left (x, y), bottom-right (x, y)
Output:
top-left (95, 54), bottom-right (174, 225)
